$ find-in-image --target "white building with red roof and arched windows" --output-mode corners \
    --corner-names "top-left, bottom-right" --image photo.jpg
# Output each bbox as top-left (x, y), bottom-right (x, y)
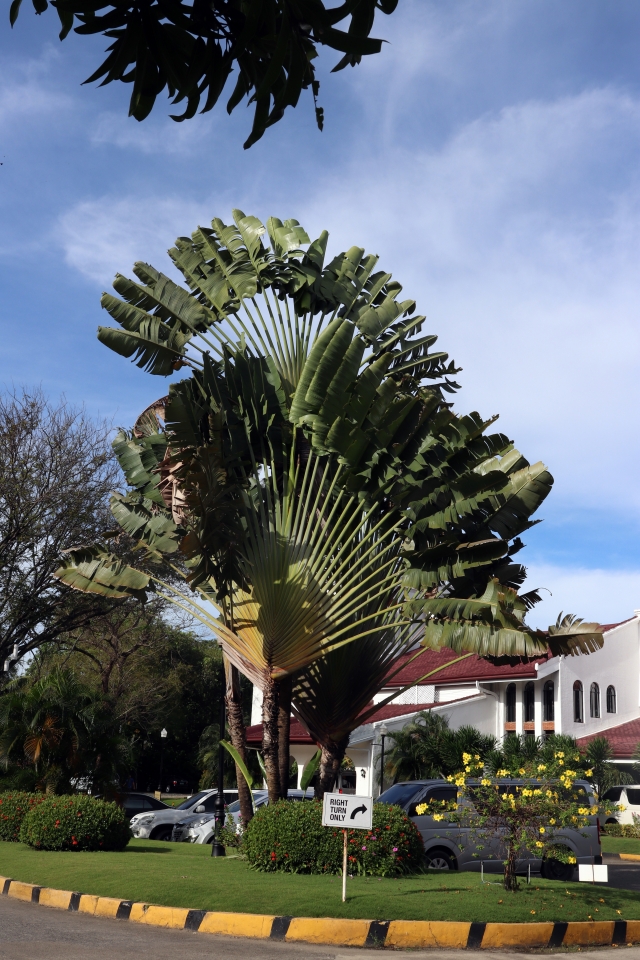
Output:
top-left (247, 610), bottom-right (640, 795)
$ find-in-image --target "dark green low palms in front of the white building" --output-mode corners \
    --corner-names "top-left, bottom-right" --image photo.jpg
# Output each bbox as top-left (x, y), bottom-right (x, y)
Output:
top-left (385, 711), bottom-right (495, 783)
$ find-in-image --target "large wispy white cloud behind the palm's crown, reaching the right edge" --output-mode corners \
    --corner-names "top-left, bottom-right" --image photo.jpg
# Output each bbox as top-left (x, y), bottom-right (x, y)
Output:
top-left (61, 88), bottom-right (640, 513)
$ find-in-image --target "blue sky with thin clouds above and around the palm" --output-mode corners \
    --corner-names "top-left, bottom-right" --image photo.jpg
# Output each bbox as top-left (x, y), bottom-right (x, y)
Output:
top-left (0, 0), bottom-right (640, 625)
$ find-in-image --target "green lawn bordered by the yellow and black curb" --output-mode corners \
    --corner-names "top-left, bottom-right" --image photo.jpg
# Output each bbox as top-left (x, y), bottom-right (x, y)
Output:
top-left (0, 840), bottom-right (640, 922)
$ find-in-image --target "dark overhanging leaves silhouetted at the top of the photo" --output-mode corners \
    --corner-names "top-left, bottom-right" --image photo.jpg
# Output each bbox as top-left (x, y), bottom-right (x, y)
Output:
top-left (10, 0), bottom-right (398, 148)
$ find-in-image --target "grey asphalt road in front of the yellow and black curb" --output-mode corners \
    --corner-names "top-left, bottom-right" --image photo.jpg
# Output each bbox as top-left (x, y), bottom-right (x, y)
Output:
top-left (0, 897), bottom-right (640, 960)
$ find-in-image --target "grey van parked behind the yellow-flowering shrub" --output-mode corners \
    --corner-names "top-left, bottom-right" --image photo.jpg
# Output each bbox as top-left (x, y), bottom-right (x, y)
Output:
top-left (376, 780), bottom-right (602, 883)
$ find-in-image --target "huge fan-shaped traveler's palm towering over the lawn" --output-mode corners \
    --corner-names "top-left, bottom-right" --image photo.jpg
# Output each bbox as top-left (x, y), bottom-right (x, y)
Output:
top-left (59, 211), bottom-right (602, 796)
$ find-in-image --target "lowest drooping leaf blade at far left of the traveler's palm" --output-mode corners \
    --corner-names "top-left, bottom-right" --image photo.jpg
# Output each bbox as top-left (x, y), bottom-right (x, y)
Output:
top-left (54, 544), bottom-right (153, 600)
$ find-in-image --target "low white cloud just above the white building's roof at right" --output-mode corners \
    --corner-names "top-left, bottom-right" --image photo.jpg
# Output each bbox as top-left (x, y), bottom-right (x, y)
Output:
top-left (527, 564), bottom-right (640, 629)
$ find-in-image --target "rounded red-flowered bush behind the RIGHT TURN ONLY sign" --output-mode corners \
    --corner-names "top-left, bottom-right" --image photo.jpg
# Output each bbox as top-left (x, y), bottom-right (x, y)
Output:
top-left (242, 800), bottom-right (424, 877)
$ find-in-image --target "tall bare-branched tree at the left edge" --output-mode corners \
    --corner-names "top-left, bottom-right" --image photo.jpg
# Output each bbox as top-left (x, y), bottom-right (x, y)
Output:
top-left (0, 390), bottom-right (118, 676)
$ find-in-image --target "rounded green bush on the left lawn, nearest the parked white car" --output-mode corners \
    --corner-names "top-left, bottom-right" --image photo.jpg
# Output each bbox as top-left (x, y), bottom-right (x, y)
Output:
top-left (20, 797), bottom-right (131, 850)
